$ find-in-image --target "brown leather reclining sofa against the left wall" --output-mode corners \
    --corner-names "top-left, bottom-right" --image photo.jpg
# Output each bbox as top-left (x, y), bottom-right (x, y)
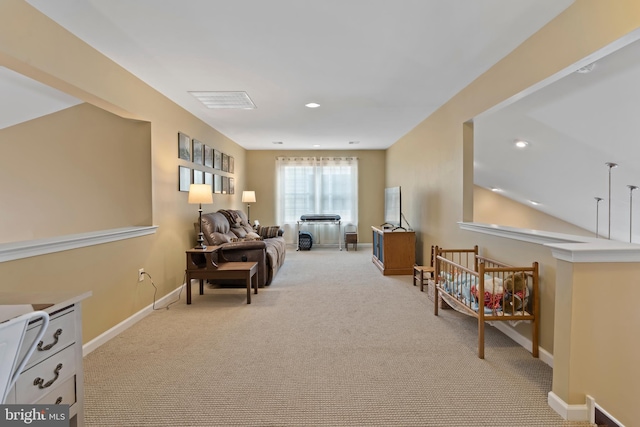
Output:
top-left (202, 209), bottom-right (286, 287)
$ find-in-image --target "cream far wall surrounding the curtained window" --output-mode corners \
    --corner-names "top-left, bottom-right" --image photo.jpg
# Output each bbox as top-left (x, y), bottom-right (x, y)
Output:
top-left (244, 150), bottom-right (385, 243)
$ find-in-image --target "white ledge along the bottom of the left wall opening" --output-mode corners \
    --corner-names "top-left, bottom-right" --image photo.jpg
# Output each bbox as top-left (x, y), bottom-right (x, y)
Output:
top-left (0, 225), bottom-right (158, 262)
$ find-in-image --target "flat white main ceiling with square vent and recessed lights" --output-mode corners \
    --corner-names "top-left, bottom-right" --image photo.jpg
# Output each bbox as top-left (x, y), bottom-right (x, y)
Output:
top-left (27, 0), bottom-right (573, 150)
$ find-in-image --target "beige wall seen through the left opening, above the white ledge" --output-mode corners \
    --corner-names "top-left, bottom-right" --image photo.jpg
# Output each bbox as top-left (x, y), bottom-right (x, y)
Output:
top-left (0, 104), bottom-right (151, 243)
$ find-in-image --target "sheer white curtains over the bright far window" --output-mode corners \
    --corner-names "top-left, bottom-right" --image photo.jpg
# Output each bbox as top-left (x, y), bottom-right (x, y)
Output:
top-left (276, 157), bottom-right (358, 243)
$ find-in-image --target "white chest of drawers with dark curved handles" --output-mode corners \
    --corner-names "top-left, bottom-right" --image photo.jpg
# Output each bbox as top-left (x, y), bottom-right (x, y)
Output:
top-left (0, 292), bottom-right (91, 426)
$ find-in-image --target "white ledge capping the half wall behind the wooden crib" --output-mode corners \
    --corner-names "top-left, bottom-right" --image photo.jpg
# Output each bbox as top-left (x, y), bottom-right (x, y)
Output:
top-left (458, 222), bottom-right (640, 263)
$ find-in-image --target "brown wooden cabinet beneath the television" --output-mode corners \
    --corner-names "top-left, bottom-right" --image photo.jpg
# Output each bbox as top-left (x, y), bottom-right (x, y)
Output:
top-left (371, 227), bottom-right (416, 276)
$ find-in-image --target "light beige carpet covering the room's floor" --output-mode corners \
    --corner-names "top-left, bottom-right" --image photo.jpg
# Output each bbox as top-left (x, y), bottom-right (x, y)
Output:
top-left (85, 245), bottom-right (589, 427)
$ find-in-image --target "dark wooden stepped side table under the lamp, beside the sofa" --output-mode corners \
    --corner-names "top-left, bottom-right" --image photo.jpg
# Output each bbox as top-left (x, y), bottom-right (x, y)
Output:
top-left (186, 246), bottom-right (258, 304)
